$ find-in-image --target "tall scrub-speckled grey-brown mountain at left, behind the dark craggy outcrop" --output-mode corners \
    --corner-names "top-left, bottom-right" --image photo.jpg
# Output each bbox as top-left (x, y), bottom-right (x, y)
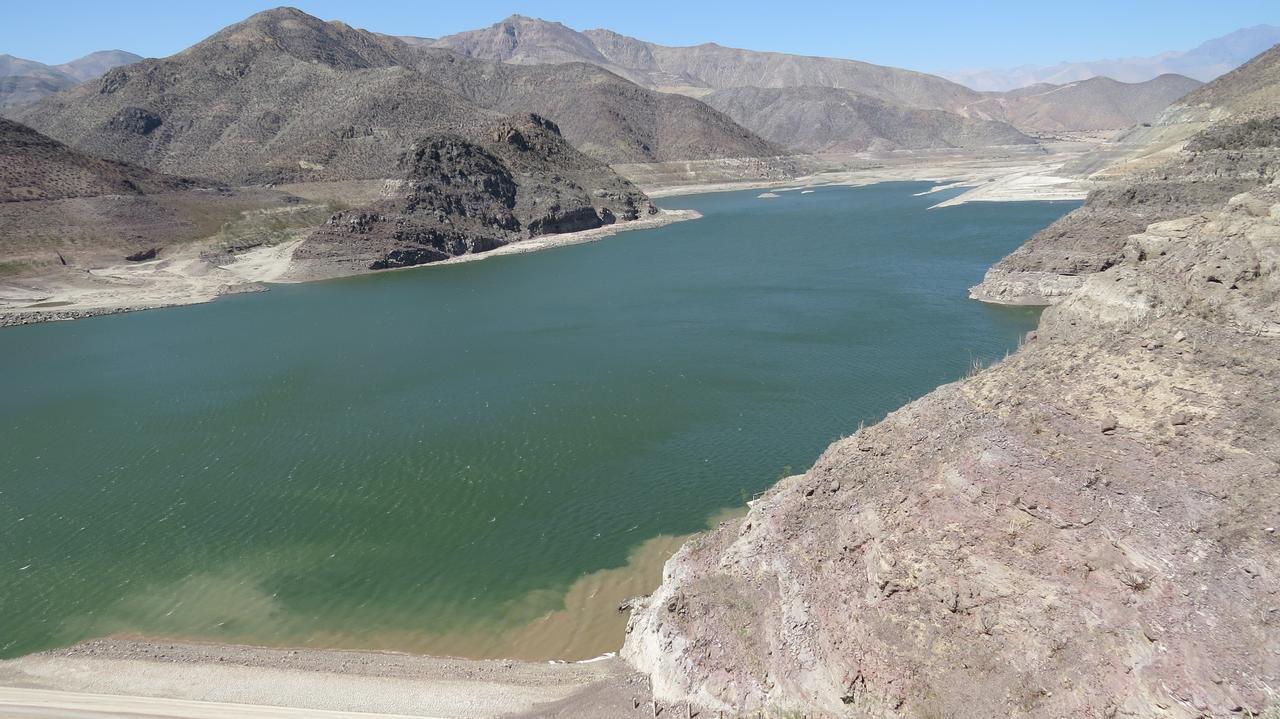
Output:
top-left (17, 8), bottom-right (777, 183)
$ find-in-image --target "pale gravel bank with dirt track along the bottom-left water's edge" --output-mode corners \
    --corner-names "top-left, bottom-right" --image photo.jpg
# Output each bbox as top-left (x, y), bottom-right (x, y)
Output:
top-left (0, 640), bottom-right (649, 719)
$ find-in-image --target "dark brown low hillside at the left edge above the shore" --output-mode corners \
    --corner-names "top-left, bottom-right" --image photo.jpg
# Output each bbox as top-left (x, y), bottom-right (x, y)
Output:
top-left (0, 118), bottom-right (197, 202)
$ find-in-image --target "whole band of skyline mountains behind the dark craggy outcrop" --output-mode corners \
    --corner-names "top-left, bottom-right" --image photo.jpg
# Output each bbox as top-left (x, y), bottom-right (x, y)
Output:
top-left (0, 8), bottom-right (1259, 172)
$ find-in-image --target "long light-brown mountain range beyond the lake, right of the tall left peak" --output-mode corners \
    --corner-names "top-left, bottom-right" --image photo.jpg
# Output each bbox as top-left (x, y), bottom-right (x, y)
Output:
top-left (435, 15), bottom-right (1196, 151)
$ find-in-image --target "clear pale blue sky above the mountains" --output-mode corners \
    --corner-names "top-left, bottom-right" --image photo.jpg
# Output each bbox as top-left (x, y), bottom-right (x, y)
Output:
top-left (0, 0), bottom-right (1280, 70)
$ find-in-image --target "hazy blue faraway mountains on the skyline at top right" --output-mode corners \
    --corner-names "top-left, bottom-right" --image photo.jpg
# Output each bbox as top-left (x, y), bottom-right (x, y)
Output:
top-left (940, 24), bottom-right (1280, 92)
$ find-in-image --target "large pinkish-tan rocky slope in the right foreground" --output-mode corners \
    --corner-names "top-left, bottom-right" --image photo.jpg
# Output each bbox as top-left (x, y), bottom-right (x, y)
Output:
top-left (623, 166), bottom-right (1280, 719)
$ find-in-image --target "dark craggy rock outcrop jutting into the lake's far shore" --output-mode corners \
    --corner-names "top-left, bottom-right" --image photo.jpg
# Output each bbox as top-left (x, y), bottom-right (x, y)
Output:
top-left (294, 115), bottom-right (657, 276)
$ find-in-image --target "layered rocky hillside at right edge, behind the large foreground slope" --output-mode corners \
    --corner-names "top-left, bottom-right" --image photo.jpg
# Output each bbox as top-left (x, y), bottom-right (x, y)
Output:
top-left (972, 47), bottom-right (1280, 304)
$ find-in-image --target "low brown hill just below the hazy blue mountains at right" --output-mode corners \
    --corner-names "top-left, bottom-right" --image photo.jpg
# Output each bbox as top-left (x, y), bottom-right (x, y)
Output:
top-left (965, 74), bottom-right (1202, 132)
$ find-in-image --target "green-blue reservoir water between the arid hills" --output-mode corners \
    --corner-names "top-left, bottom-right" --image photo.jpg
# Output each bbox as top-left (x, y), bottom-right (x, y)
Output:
top-left (0, 183), bottom-right (1076, 656)
